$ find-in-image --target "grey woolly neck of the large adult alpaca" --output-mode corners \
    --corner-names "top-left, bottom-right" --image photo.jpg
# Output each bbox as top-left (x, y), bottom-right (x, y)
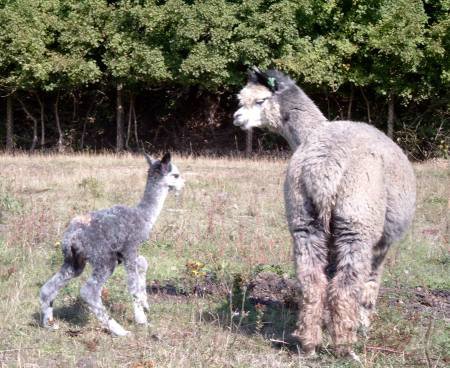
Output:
top-left (278, 89), bottom-right (328, 151)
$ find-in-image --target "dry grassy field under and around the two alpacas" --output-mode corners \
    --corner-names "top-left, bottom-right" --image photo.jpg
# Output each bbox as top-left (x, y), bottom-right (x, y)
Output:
top-left (0, 155), bottom-right (450, 368)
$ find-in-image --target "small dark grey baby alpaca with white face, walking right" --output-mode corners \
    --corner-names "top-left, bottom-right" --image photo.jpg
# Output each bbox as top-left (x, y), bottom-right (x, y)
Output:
top-left (40, 153), bottom-right (184, 336)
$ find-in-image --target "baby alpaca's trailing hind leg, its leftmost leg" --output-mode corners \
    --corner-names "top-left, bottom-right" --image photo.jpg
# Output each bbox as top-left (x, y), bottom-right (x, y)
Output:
top-left (40, 261), bottom-right (84, 329)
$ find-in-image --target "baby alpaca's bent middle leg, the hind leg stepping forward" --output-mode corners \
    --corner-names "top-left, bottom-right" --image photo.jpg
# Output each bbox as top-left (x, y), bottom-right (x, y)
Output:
top-left (80, 260), bottom-right (129, 336)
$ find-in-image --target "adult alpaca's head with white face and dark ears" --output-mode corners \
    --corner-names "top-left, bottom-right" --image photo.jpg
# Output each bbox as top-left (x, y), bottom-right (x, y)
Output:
top-left (233, 67), bottom-right (299, 131)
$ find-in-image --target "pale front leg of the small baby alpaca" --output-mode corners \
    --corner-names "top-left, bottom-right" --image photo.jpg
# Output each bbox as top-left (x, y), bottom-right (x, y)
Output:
top-left (125, 255), bottom-right (148, 324)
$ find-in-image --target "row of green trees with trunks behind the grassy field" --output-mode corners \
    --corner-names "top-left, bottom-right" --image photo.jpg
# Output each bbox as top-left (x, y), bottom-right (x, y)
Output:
top-left (0, 0), bottom-right (450, 157)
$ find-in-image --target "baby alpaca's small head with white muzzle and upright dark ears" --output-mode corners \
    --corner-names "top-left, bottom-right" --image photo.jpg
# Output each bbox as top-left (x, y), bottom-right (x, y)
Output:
top-left (144, 153), bottom-right (184, 191)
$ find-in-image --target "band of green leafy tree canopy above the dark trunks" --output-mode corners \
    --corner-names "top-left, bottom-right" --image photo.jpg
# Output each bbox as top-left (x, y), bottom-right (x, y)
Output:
top-left (0, 0), bottom-right (450, 155)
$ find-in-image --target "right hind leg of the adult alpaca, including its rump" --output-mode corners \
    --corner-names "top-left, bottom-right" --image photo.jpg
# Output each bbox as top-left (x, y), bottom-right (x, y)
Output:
top-left (328, 156), bottom-right (386, 356)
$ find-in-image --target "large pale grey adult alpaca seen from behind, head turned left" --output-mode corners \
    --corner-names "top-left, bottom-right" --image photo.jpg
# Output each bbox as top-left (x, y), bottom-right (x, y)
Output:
top-left (234, 68), bottom-right (415, 356)
